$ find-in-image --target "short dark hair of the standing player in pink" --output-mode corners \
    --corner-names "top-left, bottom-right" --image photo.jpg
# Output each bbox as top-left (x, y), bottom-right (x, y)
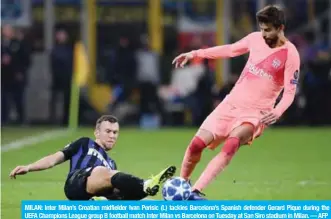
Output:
top-left (256, 5), bottom-right (286, 28)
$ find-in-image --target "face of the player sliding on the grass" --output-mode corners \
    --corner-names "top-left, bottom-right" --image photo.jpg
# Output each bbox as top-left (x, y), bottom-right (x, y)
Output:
top-left (95, 121), bottom-right (119, 150)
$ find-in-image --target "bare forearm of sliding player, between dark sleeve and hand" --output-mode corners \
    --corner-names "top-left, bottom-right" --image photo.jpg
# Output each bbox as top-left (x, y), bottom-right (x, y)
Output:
top-left (27, 152), bottom-right (64, 172)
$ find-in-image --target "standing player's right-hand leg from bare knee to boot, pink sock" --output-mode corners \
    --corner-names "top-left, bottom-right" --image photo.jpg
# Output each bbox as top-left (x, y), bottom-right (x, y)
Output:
top-left (189, 124), bottom-right (254, 200)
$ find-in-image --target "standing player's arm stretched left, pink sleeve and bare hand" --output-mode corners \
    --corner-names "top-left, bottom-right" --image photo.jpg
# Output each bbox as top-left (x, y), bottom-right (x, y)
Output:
top-left (173, 33), bottom-right (255, 67)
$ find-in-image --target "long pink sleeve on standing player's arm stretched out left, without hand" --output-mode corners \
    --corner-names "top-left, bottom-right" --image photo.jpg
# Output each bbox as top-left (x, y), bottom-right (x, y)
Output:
top-left (192, 33), bottom-right (254, 59)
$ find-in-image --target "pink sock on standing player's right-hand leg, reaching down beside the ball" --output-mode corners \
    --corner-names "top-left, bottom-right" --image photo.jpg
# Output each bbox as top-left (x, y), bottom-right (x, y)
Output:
top-left (193, 137), bottom-right (240, 191)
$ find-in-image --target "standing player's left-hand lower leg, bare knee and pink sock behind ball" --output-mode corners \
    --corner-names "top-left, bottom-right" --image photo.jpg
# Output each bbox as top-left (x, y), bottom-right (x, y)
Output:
top-left (180, 130), bottom-right (214, 180)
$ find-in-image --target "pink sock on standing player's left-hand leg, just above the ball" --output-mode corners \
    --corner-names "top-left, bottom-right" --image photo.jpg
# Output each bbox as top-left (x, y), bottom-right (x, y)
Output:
top-left (180, 136), bottom-right (206, 180)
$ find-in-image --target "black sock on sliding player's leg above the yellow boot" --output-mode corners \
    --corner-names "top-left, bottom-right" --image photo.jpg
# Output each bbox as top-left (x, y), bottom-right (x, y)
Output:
top-left (110, 172), bottom-right (147, 200)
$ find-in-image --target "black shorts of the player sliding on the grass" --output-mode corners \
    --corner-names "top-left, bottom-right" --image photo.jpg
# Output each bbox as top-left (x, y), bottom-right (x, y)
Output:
top-left (64, 167), bottom-right (123, 200)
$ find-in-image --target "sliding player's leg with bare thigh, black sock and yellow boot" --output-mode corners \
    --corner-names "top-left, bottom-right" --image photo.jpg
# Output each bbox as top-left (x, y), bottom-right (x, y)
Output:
top-left (86, 166), bottom-right (176, 200)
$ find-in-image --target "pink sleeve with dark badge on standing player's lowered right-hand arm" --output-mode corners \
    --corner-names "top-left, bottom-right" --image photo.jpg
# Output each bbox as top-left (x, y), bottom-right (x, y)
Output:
top-left (274, 46), bottom-right (300, 116)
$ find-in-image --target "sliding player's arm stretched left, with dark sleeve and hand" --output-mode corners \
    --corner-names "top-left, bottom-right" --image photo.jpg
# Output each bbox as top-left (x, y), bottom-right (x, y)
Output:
top-left (9, 139), bottom-right (82, 179)
